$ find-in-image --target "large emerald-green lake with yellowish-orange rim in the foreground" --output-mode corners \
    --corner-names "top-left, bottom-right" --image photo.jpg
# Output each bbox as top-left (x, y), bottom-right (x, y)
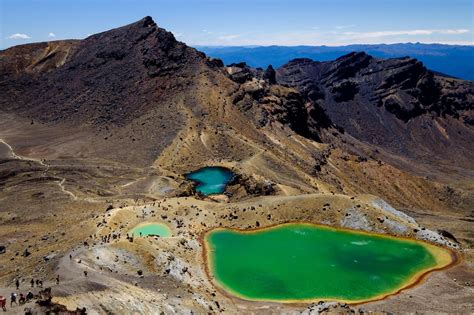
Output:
top-left (204, 224), bottom-right (452, 303)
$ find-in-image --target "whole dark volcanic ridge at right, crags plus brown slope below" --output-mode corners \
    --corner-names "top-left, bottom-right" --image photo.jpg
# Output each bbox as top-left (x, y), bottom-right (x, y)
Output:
top-left (277, 52), bottom-right (474, 168)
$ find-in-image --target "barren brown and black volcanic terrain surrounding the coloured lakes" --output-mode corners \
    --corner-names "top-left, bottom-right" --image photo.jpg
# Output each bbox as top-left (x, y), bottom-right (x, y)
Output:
top-left (0, 17), bottom-right (474, 314)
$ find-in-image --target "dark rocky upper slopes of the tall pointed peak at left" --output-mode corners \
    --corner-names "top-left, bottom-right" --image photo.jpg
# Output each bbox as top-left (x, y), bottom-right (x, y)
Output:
top-left (0, 17), bottom-right (203, 127)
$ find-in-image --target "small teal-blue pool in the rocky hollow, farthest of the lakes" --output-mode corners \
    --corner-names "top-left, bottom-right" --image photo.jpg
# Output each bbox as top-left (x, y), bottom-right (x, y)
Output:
top-left (185, 166), bottom-right (234, 196)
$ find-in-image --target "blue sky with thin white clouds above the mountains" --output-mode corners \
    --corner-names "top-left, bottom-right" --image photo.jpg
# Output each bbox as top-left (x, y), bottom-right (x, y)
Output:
top-left (0, 0), bottom-right (474, 49)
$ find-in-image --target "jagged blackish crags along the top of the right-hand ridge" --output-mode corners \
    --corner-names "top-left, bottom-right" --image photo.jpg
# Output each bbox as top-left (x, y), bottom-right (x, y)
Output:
top-left (278, 52), bottom-right (474, 122)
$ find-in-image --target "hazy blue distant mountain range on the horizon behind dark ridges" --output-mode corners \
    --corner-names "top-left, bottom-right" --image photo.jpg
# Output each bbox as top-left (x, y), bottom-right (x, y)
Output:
top-left (197, 43), bottom-right (474, 81)
